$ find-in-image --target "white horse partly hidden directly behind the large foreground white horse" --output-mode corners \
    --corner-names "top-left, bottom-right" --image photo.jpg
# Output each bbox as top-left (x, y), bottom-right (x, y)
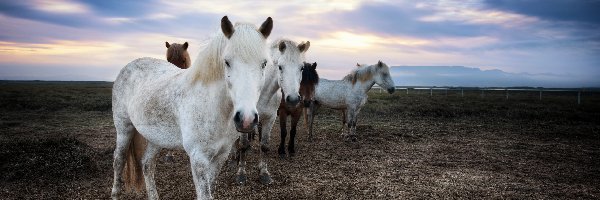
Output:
top-left (236, 39), bottom-right (310, 184)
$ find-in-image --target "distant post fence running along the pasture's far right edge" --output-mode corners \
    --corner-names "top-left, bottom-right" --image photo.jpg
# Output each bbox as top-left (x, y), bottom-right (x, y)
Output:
top-left (372, 85), bottom-right (600, 104)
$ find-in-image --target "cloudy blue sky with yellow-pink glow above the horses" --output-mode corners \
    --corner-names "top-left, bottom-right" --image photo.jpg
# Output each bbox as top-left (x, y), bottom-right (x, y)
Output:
top-left (0, 0), bottom-right (600, 87)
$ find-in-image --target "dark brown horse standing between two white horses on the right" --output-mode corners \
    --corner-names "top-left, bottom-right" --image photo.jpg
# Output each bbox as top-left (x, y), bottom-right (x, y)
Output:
top-left (277, 63), bottom-right (319, 158)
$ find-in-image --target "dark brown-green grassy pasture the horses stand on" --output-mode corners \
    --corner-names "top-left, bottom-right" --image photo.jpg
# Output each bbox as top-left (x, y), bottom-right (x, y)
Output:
top-left (0, 81), bottom-right (600, 199)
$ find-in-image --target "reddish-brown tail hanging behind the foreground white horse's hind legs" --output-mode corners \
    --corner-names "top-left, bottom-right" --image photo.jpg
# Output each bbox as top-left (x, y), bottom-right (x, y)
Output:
top-left (123, 129), bottom-right (148, 192)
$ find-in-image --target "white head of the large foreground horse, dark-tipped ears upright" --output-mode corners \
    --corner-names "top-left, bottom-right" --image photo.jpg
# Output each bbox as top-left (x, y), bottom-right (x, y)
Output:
top-left (221, 16), bottom-right (273, 132)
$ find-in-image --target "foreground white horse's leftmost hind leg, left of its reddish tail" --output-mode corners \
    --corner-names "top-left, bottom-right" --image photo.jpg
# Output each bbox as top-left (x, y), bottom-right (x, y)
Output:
top-left (111, 120), bottom-right (135, 199)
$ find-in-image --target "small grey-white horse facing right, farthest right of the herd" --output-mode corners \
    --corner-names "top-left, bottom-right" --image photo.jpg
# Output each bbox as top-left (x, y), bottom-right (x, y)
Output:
top-left (307, 61), bottom-right (396, 141)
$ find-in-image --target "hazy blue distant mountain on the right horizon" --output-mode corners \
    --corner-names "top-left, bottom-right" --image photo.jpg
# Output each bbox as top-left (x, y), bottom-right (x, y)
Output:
top-left (390, 66), bottom-right (599, 87)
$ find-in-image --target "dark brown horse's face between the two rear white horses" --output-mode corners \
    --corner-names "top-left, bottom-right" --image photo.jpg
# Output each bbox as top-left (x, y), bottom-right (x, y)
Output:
top-left (300, 63), bottom-right (319, 107)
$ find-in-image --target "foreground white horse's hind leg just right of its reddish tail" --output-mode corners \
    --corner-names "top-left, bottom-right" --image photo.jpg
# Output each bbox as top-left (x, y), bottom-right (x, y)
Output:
top-left (142, 142), bottom-right (160, 199)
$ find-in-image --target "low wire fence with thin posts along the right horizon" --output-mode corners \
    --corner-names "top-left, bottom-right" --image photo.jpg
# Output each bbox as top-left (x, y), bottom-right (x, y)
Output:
top-left (371, 85), bottom-right (600, 104)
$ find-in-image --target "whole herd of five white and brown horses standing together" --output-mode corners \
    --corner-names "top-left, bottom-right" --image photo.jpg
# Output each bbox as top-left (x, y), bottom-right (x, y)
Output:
top-left (111, 16), bottom-right (394, 199)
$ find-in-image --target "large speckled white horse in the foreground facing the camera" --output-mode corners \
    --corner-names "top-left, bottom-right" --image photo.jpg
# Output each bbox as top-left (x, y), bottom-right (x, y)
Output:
top-left (111, 16), bottom-right (273, 199)
